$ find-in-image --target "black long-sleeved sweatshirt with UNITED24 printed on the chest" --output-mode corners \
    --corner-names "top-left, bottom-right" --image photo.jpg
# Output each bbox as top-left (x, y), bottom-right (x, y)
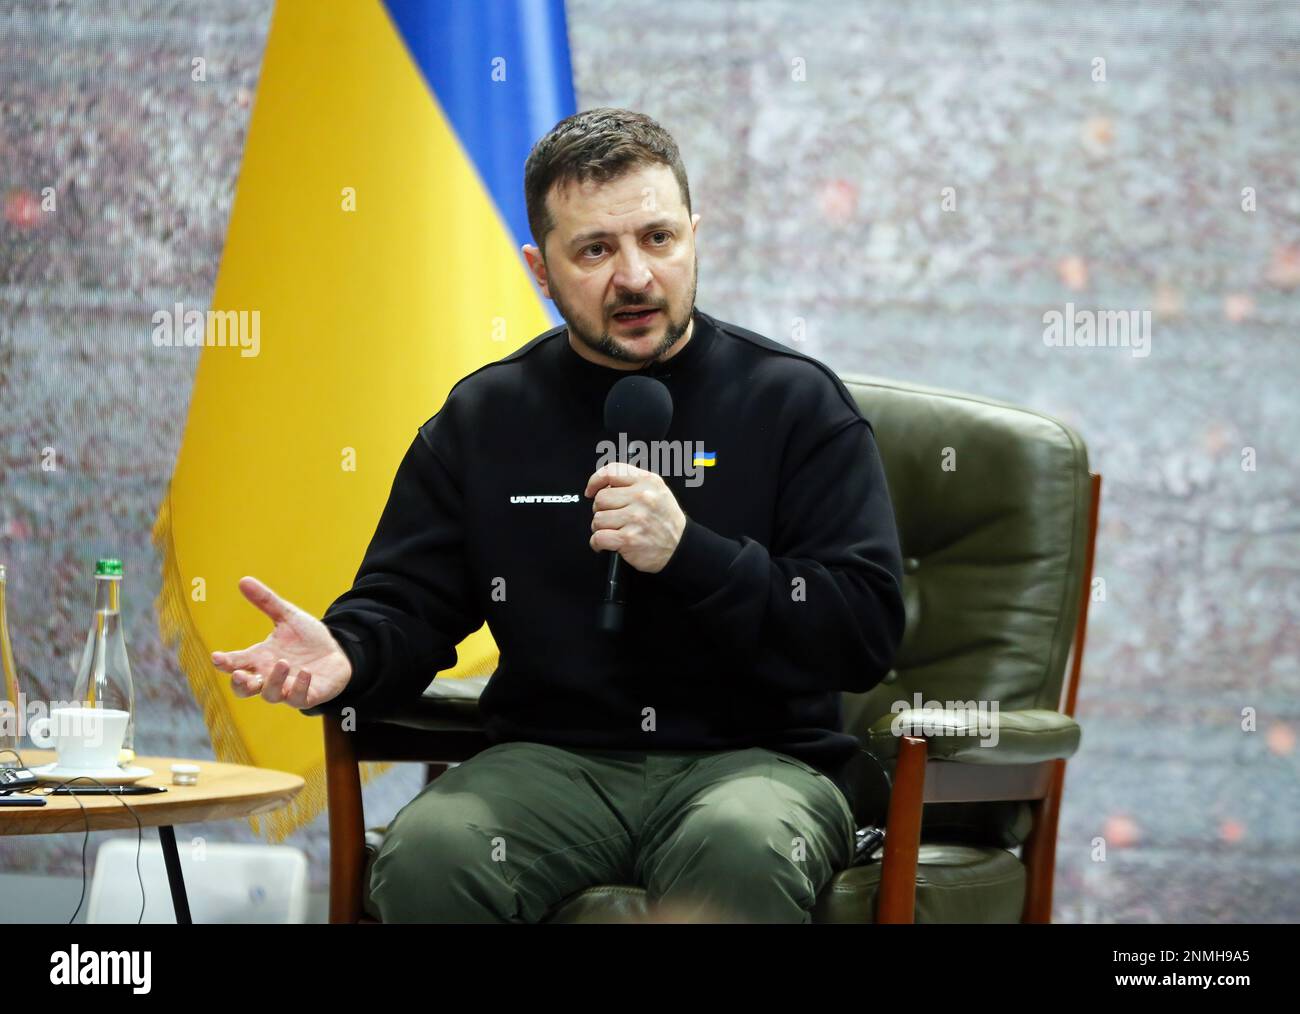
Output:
top-left (307, 308), bottom-right (904, 806)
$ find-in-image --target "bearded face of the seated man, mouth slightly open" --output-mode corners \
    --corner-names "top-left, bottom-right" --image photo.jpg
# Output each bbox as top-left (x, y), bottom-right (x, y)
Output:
top-left (524, 165), bottom-right (699, 369)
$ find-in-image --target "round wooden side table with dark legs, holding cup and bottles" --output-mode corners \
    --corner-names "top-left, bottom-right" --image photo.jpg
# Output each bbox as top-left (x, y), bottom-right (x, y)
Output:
top-left (0, 750), bottom-right (304, 923)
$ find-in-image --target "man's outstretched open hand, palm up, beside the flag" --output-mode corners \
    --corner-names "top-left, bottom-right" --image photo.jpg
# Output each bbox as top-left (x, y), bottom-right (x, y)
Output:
top-left (212, 577), bottom-right (352, 709)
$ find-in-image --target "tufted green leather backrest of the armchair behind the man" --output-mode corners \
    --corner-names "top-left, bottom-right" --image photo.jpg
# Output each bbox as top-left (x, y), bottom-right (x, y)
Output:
top-left (841, 374), bottom-right (1091, 736)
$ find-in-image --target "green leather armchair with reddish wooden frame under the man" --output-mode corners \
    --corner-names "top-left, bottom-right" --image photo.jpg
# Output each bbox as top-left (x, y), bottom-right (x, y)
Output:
top-left (324, 376), bottom-right (1101, 923)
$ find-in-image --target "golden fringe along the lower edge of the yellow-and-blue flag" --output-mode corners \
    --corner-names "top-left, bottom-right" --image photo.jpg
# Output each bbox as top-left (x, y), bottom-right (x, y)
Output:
top-left (152, 486), bottom-right (393, 842)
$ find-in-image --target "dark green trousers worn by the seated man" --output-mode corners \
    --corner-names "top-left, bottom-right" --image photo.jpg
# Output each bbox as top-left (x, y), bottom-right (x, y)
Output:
top-left (371, 742), bottom-right (854, 923)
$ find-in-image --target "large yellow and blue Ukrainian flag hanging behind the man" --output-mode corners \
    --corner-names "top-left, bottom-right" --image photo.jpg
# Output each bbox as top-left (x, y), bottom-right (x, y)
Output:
top-left (153, 0), bottom-right (575, 841)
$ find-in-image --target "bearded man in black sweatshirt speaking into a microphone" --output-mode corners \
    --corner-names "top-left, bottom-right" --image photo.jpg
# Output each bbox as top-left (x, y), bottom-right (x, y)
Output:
top-left (213, 109), bottom-right (904, 922)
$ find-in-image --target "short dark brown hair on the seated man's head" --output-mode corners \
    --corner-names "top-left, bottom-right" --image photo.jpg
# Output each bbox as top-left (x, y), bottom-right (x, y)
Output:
top-left (524, 105), bottom-right (690, 259)
